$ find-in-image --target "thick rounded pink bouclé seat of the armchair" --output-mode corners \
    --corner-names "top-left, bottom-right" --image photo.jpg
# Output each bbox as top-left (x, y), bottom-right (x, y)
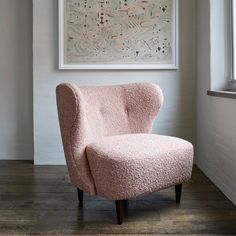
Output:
top-left (86, 134), bottom-right (193, 200)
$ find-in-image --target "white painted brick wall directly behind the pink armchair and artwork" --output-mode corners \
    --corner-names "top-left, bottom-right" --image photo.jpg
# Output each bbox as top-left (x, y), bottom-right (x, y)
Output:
top-left (33, 0), bottom-right (196, 164)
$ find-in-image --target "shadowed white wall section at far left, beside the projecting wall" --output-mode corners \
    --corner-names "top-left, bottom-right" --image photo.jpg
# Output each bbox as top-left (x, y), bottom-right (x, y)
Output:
top-left (0, 0), bottom-right (33, 160)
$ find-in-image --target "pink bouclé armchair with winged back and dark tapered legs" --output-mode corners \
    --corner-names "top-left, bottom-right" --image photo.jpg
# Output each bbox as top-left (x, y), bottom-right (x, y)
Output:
top-left (56, 83), bottom-right (193, 224)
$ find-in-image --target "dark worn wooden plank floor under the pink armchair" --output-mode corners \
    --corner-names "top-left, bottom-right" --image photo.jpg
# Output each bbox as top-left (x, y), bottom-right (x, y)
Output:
top-left (0, 161), bottom-right (236, 236)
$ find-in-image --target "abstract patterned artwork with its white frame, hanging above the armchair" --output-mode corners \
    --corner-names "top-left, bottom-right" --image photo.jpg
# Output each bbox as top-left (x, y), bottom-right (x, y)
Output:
top-left (58, 0), bottom-right (179, 70)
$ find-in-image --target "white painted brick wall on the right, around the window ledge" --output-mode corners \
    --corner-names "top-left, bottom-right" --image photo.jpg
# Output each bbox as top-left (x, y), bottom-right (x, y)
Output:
top-left (197, 0), bottom-right (236, 204)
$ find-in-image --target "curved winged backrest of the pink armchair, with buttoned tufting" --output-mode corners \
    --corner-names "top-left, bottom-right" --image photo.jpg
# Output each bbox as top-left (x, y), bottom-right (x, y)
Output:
top-left (56, 83), bottom-right (163, 194)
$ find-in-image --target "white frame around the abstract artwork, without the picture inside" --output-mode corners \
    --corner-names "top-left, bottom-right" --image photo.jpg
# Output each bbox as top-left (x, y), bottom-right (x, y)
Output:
top-left (58, 0), bottom-right (179, 70)
